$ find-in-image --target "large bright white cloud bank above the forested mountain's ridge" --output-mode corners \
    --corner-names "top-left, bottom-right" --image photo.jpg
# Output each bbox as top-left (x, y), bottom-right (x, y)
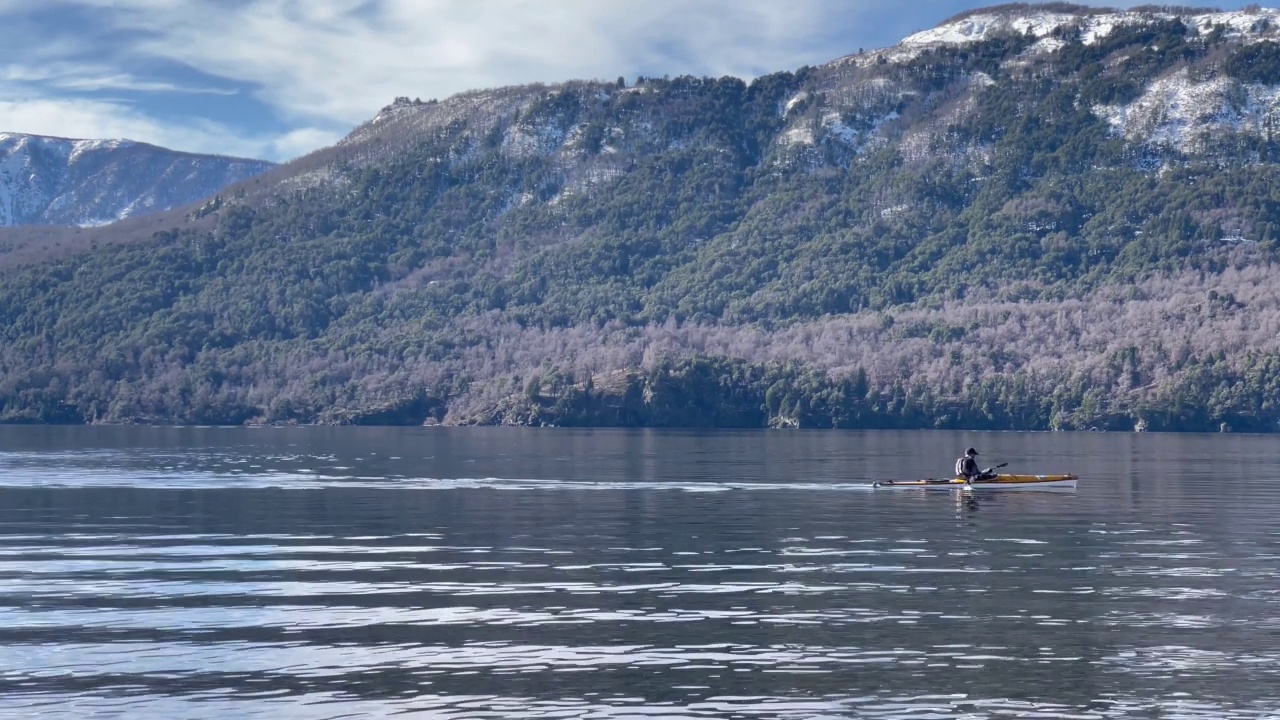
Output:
top-left (82, 0), bottom-right (849, 124)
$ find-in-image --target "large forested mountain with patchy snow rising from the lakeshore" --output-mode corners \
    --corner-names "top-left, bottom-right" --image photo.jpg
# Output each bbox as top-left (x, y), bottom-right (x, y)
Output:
top-left (0, 3), bottom-right (1280, 432)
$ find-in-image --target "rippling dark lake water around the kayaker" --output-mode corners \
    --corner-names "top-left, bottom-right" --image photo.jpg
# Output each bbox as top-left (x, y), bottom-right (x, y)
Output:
top-left (0, 427), bottom-right (1280, 720)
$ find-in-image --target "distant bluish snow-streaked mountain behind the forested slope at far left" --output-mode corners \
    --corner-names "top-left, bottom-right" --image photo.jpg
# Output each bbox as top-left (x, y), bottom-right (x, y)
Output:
top-left (0, 132), bottom-right (273, 227)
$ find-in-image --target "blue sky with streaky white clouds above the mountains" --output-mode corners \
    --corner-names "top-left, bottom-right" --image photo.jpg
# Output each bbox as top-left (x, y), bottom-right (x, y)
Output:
top-left (0, 0), bottom-right (1270, 161)
